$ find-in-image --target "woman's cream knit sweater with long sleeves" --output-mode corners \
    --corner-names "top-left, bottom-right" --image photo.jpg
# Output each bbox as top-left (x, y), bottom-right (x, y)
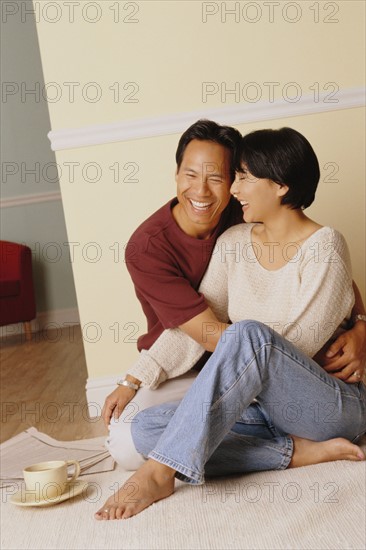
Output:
top-left (128, 223), bottom-right (354, 389)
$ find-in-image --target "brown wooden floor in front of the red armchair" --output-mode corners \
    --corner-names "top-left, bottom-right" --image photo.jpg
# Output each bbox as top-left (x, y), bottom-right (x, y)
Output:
top-left (0, 327), bottom-right (107, 442)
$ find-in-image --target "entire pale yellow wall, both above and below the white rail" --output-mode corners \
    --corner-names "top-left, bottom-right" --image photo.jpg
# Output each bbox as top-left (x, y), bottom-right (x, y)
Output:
top-left (33, 0), bottom-right (365, 378)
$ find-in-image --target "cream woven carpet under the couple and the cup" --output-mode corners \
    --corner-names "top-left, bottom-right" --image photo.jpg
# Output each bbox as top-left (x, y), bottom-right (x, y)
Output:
top-left (1, 439), bottom-right (366, 550)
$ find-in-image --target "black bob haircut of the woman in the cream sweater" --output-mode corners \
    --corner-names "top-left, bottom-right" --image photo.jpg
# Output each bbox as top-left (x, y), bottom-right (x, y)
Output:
top-left (236, 128), bottom-right (320, 209)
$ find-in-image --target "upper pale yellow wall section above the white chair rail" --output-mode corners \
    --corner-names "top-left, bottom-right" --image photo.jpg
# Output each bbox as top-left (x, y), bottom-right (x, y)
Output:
top-left (34, 0), bottom-right (365, 129)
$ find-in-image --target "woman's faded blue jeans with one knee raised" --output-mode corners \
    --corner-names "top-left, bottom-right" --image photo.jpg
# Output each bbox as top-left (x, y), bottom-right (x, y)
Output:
top-left (132, 321), bottom-right (366, 484)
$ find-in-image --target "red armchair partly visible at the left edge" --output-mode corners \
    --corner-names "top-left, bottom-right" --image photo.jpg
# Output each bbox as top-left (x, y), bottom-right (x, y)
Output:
top-left (0, 241), bottom-right (36, 341)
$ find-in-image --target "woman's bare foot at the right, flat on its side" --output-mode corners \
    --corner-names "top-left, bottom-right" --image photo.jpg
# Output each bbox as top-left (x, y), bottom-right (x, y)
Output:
top-left (288, 435), bottom-right (365, 468)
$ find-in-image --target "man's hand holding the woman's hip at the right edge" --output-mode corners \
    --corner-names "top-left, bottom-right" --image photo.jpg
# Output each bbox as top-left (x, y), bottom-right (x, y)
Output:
top-left (322, 321), bottom-right (366, 384)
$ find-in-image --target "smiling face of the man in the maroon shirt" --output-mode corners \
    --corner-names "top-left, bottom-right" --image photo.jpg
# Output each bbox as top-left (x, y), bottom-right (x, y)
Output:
top-left (173, 139), bottom-right (231, 238)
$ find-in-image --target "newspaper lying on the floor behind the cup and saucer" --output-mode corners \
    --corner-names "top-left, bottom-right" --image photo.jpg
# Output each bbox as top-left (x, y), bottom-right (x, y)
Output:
top-left (0, 427), bottom-right (115, 488)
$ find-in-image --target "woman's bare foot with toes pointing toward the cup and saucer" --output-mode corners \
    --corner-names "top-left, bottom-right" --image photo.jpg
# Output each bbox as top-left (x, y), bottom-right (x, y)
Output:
top-left (94, 459), bottom-right (175, 520)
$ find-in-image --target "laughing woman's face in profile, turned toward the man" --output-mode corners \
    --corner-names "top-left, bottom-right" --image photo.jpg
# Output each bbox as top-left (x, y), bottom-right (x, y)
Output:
top-left (230, 164), bottom-right (288, 222)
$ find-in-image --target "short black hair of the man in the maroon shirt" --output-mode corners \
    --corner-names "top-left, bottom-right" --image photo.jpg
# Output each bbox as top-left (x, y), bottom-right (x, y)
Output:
top-left (175, 119), bottom-right (242, 182)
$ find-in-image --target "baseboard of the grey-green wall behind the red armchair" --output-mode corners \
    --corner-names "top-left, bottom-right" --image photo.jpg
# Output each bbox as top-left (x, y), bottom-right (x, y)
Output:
top-left (0, 308), bottom-right (80, 338)
